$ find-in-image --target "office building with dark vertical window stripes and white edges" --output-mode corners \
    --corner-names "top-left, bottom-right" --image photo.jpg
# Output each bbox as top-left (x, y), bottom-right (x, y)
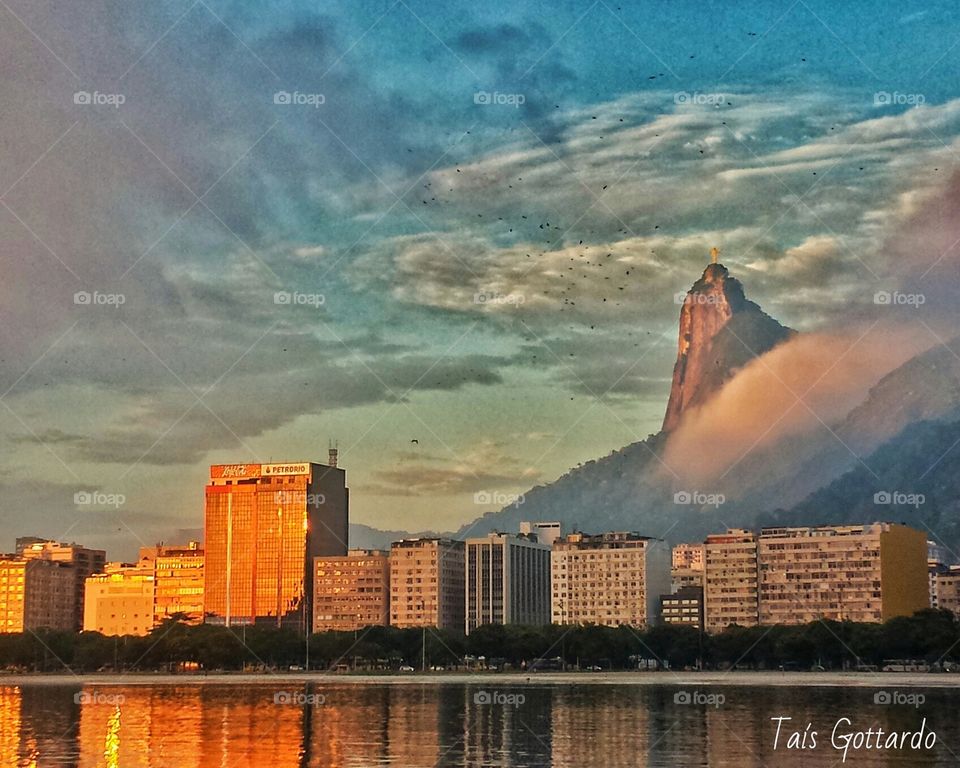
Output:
top-left (466, 531), bottom-right (550, 634)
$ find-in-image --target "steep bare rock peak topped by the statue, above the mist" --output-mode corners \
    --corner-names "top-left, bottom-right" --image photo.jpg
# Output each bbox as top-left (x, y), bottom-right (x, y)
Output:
top-left (663, 263), bottom-right (794, 432)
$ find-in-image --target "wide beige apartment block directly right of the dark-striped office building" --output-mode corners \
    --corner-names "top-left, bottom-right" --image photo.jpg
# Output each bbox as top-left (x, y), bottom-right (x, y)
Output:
top-left (550, 532), bottom-right (670, 627)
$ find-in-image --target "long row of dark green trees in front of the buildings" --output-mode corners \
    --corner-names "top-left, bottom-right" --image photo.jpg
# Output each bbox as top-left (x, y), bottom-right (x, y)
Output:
top-left (0, 610), bottom-right (960, 672)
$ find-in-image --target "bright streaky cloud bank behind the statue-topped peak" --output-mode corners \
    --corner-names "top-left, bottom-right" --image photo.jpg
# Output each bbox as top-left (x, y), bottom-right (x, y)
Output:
top-left (351, 91), bottom-right (960, 340)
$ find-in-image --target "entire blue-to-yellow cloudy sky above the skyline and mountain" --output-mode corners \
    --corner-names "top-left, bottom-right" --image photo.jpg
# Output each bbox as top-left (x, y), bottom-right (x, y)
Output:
top-left (0, 0), bottom-right (960, 558)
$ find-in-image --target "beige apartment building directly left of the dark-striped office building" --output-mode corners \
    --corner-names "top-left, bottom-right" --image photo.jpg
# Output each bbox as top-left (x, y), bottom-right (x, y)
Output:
top-left (390, 538), bottom-right (466, 632)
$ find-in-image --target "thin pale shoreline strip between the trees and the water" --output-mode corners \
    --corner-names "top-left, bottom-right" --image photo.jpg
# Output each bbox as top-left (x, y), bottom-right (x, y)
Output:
top-left (0, 670), bottom-right (960, 688)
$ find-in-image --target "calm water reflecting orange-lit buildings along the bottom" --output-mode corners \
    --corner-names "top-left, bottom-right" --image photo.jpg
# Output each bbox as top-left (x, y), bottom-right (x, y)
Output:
top-left (0, 676), bottom-right (960, 768)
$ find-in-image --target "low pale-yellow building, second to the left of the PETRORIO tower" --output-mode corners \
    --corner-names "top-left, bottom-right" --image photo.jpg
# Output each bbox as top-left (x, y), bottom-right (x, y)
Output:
top-left (83, 561), bottom-right (155, 635)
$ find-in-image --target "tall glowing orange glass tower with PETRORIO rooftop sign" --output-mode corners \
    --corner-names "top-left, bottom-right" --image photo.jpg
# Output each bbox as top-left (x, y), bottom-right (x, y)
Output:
top-left (204, 460), bottom-right (349, 631)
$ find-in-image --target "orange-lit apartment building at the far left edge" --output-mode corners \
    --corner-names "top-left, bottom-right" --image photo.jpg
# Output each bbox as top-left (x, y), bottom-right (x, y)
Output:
top-left (0, 555), bottom-right (76, 633)
